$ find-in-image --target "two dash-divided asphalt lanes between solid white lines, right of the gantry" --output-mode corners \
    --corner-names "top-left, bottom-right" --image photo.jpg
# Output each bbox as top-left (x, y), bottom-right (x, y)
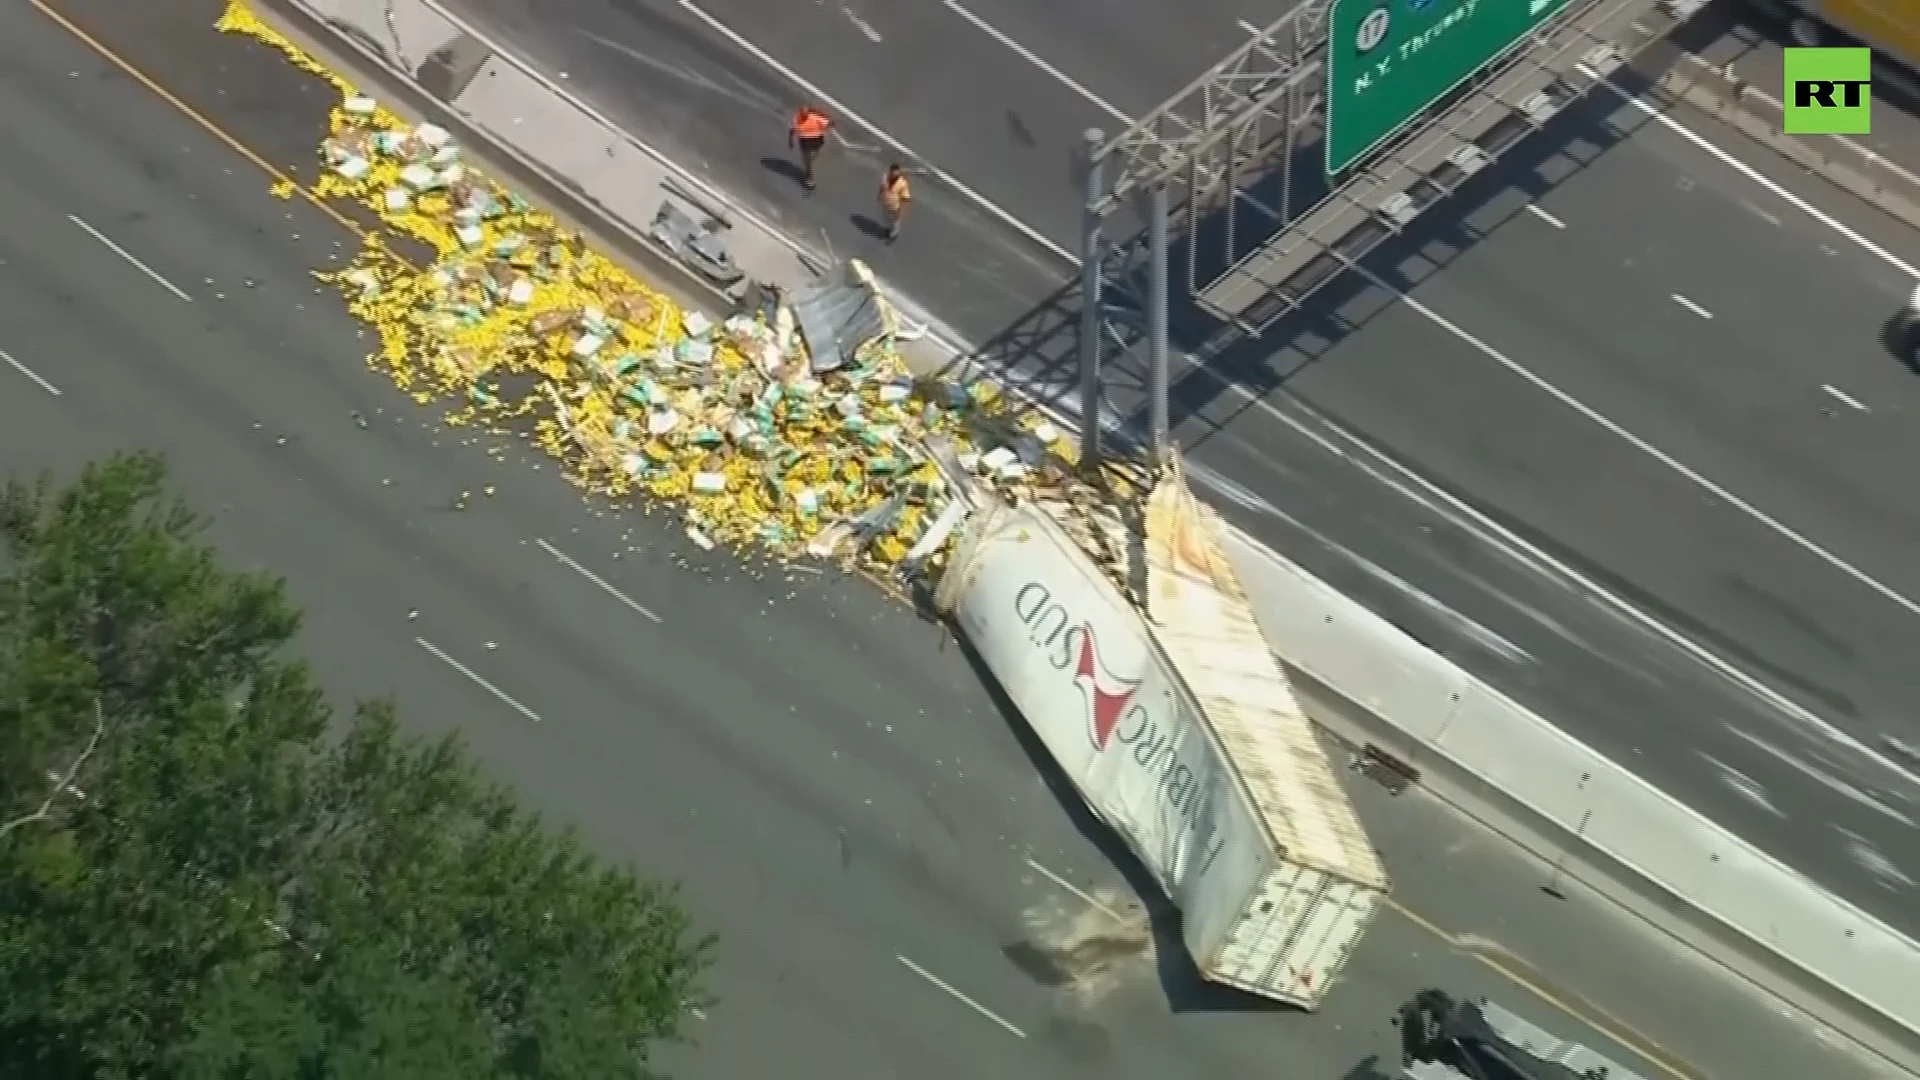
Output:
top-left (1443, 122), bottom-right (1920, 588)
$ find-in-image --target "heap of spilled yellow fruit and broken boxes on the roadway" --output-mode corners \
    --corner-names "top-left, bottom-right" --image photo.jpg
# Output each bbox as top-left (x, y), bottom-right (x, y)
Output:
top-left (219, 0), bottom-right (1127, 578)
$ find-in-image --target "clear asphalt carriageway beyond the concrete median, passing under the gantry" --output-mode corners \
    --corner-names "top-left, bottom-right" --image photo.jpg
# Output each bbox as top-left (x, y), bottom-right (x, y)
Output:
top-left (439, 0), bottom-right (1920, 932)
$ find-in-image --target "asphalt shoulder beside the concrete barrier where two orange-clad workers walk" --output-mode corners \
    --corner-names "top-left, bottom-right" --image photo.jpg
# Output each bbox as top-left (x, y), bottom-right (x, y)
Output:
top-left (432, 0), bottom-right (1068, 340)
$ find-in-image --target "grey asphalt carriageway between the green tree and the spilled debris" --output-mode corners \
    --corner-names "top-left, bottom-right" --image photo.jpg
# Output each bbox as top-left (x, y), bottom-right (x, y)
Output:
top-left (0, 2), bottom-right (1872, 1080)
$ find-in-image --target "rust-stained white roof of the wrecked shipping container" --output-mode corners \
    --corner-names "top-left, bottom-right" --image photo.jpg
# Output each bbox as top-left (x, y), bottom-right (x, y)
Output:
top-left (1146, 457), bottom-right (1386, 890)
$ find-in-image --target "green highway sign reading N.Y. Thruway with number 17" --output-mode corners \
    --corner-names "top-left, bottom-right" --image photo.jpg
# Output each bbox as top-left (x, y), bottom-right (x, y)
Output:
top-left (1327, 0), bottom-right (1569, 175)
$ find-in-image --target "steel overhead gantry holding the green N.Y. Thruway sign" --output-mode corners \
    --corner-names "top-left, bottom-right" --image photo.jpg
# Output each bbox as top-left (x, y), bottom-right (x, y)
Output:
top-left (1082, 0), bottom-right (1703, 465)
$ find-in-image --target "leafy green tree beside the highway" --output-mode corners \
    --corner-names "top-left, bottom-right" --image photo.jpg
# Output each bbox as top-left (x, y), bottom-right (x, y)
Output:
top-left (0, 455), bottom-right (710, 1080)
